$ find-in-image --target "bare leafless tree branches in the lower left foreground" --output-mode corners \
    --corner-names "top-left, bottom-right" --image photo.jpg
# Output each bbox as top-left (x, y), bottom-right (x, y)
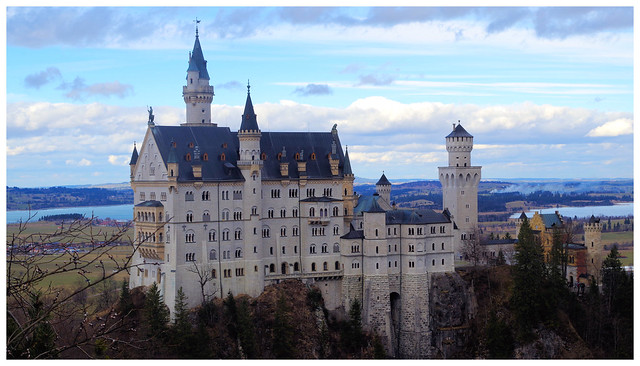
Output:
top-left (6, 215), bottom-right (148, 358)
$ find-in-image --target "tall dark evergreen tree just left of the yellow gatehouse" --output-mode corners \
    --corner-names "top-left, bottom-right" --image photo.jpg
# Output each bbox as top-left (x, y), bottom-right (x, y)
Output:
top-left (510, 218), bottom-right (545, 340)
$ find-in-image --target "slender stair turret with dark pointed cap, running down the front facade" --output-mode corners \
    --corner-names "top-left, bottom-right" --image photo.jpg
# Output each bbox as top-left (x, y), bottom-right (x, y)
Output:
top-left (237, 83), bottom-right (265, 296)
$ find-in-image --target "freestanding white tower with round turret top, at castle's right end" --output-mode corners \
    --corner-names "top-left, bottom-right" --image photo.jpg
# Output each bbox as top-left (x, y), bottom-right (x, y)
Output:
top-left (438, 121), bottom-right (482, 254)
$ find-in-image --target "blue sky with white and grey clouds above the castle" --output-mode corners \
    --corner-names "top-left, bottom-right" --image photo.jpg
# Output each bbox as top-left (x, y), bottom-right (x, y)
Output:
top-left (6, 2), bottom-right (634, 187)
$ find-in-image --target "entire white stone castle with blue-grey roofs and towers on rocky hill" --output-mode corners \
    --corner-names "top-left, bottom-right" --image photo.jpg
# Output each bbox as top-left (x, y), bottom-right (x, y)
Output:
top-left (130, 30), bottom-right (480, 357)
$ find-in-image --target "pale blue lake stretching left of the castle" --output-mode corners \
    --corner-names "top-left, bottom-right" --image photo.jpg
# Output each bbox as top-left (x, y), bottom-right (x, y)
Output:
top-left (7, 205), bottom-right (133, 224)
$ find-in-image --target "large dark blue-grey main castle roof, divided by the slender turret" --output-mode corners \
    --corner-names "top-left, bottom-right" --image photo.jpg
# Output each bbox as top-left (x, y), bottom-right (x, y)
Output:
top-left (151, 125), bottom-right (344, 181)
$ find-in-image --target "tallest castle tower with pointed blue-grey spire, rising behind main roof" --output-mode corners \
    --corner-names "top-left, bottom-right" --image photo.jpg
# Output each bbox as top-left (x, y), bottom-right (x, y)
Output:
top-left (182, 25), bottom-right (215, 126)
